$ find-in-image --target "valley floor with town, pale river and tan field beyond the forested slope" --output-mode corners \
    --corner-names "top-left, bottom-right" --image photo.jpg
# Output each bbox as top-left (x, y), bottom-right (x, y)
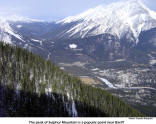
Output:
top-left (59, 60), bottom-right (156, 116)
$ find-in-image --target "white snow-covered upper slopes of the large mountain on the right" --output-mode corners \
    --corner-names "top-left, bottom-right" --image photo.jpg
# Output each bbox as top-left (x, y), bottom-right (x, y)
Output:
top-left (57, 0), bottom-right (156, 42)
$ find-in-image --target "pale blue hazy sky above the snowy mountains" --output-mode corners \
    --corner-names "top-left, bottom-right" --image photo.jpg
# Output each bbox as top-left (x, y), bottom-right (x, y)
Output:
top-left (0, 0), bottom-right (156, 20)
